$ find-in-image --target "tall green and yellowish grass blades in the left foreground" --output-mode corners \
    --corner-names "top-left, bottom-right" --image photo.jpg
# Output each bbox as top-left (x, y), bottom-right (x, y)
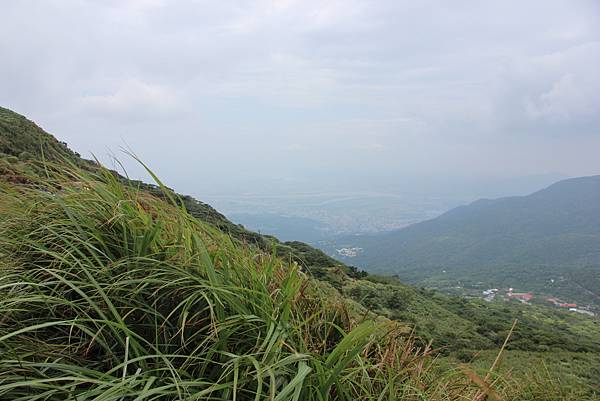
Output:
top-left (0, 161), bottom-right (580, 401)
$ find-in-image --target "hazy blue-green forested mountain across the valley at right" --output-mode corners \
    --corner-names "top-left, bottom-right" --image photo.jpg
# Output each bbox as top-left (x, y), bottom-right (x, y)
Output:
top-left (326, 176), bottom-right (600, 304)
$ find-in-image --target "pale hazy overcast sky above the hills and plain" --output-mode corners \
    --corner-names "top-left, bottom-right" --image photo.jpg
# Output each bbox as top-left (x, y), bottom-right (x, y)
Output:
top-left (0, 0), bottom-right (600, 195)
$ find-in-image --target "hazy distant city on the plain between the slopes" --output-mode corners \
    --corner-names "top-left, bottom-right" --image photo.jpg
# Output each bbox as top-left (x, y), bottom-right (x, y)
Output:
top-left (205, 192), bottom-right (465, 239)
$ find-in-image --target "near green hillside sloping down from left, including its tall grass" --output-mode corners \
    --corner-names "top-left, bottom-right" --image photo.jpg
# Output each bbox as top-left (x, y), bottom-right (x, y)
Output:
top-left (0, 109), bottom-right (600, 399)
